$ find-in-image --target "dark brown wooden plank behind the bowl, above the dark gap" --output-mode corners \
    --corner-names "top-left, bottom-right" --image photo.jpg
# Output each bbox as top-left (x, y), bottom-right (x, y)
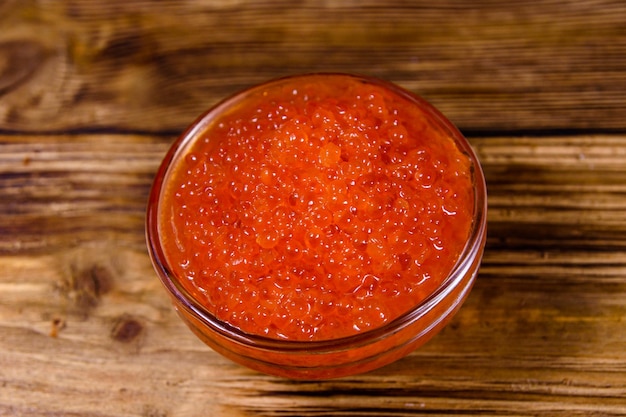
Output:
top-left (0, 0), bottom-right (626, 132)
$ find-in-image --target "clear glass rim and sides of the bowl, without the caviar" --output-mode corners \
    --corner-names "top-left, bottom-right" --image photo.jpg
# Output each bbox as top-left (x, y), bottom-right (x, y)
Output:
top-left (146, 74), bottom-right (487, 380)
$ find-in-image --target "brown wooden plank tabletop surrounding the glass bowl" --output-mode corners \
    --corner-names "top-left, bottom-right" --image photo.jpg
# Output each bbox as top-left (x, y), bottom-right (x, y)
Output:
top-left (0, 0), bottom-right (626, 417)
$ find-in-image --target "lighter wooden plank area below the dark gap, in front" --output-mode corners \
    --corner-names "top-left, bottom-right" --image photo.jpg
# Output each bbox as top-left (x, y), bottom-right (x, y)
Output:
top-left (0, 134), bottom-right (626, 417)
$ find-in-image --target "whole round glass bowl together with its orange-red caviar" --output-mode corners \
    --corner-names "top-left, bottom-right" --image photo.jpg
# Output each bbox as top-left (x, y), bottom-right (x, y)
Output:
top-left (147, 74), bottom-right (486, 379)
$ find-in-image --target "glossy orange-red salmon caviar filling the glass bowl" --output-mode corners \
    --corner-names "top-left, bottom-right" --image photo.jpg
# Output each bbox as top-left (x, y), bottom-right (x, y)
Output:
top-left (159, 76), bottom-right (475, 341)
